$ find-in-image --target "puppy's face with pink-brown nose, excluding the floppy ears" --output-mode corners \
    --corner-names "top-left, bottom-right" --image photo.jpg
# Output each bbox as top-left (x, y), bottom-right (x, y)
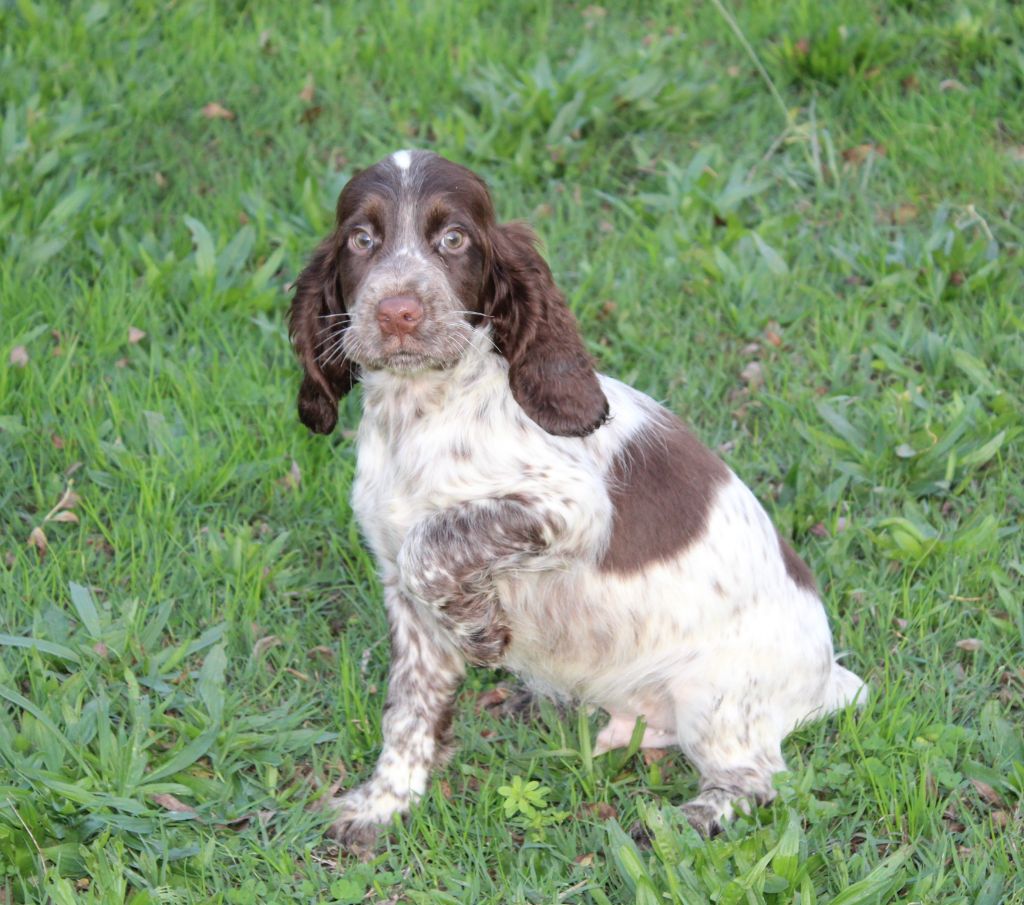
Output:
top-left (325, 152), bottom-right (495, 371)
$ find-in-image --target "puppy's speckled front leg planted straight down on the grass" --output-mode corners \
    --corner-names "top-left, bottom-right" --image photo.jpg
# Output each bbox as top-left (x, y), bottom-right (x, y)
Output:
top-left (330, 588), bottom-right (465, 853)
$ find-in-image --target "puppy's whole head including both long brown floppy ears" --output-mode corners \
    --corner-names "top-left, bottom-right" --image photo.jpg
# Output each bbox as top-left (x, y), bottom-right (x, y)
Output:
top-left (291, 150), bottom-right (607, 436)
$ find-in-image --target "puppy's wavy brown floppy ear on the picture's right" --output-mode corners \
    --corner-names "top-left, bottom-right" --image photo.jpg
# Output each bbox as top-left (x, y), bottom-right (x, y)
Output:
top-left (483, 223), bottom-right (608, 437)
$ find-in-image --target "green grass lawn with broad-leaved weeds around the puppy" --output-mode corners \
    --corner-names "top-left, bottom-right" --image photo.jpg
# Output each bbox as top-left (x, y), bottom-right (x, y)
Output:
top-left (0, 0), bottom-right (1024, 905)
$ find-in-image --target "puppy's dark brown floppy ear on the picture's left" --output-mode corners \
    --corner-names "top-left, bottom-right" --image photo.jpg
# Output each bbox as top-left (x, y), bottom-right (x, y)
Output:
top-left (289, 239), bottom-right (356, 434)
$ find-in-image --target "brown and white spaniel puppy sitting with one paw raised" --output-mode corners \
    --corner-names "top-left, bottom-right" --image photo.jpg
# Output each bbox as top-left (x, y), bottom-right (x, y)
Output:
top-left (291, 150), bottom-right (864, 848)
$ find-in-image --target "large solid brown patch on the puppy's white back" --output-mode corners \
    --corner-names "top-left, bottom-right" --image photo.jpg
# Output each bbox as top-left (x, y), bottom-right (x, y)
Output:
top-left (600, 413), bottom-right (729, 573)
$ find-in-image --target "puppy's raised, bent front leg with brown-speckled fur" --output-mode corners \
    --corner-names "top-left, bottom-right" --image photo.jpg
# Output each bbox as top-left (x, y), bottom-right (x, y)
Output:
top-left (398, 497), bottom-right (557, 666)
